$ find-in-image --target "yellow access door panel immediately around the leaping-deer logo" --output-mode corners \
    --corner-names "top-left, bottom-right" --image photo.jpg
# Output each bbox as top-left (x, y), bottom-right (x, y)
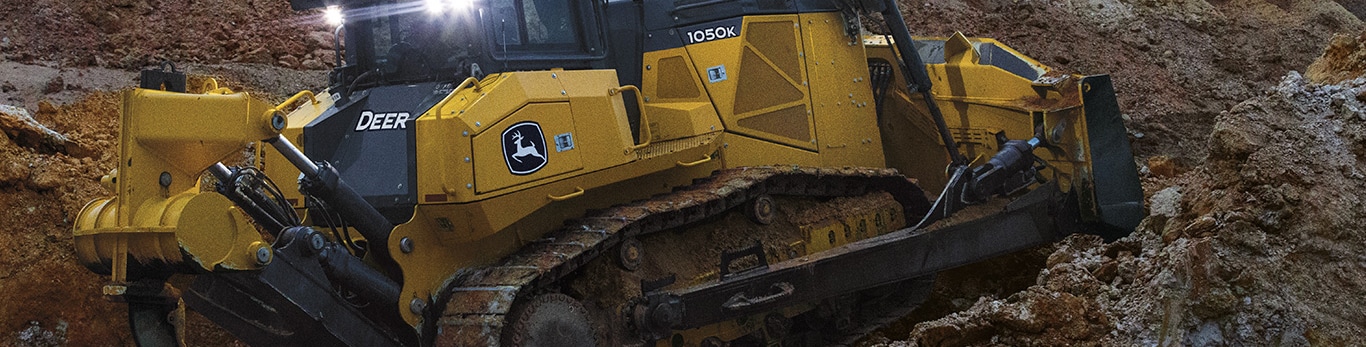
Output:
top-left (474, 102), bottom-right (583, 194)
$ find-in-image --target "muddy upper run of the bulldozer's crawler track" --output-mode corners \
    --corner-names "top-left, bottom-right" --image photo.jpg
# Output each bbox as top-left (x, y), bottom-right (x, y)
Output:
top-left (436, 167), bottom-right (930, 346)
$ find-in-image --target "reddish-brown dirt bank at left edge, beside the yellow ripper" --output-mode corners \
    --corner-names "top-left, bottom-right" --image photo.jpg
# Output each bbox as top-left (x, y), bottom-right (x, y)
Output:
top-left (0, 93), bottom-right (127, 346)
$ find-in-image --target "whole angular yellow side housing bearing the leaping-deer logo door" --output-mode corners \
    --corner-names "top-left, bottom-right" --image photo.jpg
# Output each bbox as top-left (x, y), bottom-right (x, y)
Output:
top-left (417, 70), bottom-right (634, 204)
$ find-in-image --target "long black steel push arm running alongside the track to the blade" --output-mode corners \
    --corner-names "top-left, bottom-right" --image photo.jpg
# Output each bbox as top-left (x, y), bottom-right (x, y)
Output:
top-left (672, 184), bottom-right (1075, 329)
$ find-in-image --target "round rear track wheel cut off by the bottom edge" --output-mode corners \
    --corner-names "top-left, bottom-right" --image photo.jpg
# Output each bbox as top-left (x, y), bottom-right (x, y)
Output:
top-left (503, 294), bottom-right (600, 347)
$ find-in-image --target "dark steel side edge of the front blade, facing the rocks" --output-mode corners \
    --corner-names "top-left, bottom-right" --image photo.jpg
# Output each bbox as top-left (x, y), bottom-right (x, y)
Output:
top-left (1082, 75), bottom-right (1147, 240)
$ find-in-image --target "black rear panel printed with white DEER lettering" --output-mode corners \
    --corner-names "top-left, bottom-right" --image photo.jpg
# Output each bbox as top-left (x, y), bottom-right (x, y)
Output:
top-left (302, 82), bottom-right (444, 224)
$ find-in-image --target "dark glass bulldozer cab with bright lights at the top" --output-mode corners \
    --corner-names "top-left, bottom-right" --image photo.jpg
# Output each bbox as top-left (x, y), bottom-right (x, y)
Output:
top-left (312, 0), bottom-right (607, 87)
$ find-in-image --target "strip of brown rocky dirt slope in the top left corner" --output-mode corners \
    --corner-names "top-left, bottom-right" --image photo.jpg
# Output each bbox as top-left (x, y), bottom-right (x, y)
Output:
top-left (0, 0), bottom-right (333, 70)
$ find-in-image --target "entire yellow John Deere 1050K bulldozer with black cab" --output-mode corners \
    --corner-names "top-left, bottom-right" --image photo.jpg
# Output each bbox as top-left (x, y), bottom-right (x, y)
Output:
top-left (74, 0), bottom-right (1145, 346)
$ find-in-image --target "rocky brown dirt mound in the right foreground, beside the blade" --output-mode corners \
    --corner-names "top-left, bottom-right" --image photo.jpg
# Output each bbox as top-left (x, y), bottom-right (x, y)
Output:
top-left (874, 46), bottom-right (1366, 346)
